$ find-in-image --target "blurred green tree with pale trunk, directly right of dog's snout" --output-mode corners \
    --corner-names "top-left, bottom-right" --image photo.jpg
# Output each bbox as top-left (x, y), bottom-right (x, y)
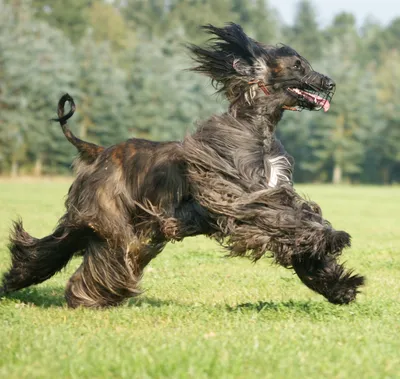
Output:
top-left (303, 36), bottom-right (377, 183)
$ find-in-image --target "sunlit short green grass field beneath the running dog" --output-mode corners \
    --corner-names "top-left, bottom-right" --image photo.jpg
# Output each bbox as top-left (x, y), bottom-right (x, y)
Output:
top-left (0, 180), bottom-right (400, 379)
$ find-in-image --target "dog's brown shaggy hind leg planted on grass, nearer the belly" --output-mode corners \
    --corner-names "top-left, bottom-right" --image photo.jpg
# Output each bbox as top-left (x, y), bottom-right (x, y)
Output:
top-left (65, 236), bottom-right (142, 308)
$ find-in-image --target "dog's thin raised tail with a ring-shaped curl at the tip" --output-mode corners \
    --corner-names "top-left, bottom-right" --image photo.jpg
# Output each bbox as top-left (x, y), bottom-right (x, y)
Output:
top-left (52, 93), bottom-right (104, 163)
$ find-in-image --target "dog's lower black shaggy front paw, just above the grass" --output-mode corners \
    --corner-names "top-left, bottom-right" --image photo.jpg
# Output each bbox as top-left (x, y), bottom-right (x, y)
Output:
top-left (292, 255), bottom-right (364, 304)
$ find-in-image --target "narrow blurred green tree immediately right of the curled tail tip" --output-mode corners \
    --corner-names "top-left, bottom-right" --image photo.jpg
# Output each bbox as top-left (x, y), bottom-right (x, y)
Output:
top-left (73, 33), bottom-right (129, 145)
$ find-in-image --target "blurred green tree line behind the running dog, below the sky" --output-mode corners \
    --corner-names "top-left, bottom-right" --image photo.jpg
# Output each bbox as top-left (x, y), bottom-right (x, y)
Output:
top-left (0, 0), bottom-right (400, 184)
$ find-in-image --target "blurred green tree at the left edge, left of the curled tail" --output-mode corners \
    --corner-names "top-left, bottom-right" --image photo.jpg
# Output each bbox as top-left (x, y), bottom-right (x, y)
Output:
top-left (0, 2), bottom-right (75, 174)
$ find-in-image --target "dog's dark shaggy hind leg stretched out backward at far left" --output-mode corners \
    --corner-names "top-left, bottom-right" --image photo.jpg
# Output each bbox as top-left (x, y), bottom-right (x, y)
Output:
top-left (0, 221), bottom-right (92, 295)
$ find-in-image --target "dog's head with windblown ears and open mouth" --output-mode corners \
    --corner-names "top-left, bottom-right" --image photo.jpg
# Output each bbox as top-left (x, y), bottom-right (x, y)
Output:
top-left (189, 23), bottom-right (335, 111)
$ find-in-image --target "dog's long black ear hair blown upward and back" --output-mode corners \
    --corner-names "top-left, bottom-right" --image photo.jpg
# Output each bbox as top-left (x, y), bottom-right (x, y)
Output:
top-left (188, 23), bottom-right (267, 91)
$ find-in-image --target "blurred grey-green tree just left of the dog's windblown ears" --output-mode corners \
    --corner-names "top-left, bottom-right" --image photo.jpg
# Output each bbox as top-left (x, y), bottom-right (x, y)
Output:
top-left (124, 35), bottom-right (225, 140)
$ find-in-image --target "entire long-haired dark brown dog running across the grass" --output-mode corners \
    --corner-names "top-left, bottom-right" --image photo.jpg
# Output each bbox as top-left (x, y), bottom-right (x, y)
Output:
top-left (2, 24), bottom-right (363, 307)
